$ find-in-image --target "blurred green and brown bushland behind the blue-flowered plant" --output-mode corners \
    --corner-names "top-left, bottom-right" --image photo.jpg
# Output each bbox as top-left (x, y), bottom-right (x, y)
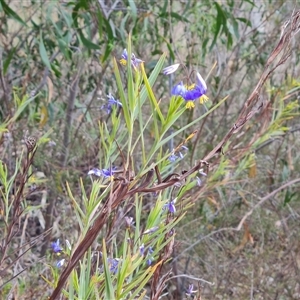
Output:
top-left (0, 0), bottom-right (300, 299)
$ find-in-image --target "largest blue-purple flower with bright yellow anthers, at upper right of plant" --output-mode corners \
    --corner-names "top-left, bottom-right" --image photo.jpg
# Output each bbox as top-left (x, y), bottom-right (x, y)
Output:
top-left (172, 73), bottom-right (208, 108)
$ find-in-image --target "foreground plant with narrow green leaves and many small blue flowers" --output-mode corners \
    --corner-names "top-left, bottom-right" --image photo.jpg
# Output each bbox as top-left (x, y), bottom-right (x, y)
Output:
top-left (43, 41), bottom-right (225, 300)
